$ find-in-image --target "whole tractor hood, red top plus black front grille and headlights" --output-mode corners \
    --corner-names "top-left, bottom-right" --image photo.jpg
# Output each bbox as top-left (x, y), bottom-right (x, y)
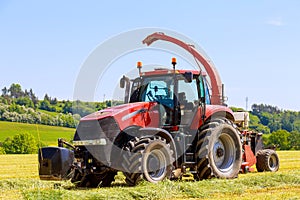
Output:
top-left (73, 102), bottom-right (159, 166)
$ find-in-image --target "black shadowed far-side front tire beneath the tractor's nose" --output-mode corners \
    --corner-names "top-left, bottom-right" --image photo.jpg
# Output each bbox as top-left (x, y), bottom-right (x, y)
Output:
top-left (71, 170), bottom-right (117, 188)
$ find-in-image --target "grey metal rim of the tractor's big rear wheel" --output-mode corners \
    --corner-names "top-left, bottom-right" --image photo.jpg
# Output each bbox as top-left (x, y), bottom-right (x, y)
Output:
top-left (213, 133), bottom-right (236, 172)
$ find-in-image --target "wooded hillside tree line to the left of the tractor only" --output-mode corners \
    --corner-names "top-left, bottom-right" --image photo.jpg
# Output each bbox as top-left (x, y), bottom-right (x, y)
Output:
top-left (0, 83), bottom-right (121, 128)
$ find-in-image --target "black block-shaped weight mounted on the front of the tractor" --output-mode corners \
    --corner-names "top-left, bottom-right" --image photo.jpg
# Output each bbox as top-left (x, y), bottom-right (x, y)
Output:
top-left (38, 147), bottom-right (74, 180)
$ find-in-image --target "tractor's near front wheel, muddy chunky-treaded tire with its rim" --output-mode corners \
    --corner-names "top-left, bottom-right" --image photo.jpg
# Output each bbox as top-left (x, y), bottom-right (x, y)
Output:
top-left (122, 137), bottom-right (174, 186)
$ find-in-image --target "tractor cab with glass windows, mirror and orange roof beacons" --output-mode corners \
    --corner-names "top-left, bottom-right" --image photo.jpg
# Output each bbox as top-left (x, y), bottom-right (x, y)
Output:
top-left (120, 58), bottom-right (210, 128)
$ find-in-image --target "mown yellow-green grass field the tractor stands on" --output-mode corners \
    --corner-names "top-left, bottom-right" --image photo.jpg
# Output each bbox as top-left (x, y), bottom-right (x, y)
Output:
top-left (0, 151), bottom-right (300, 200)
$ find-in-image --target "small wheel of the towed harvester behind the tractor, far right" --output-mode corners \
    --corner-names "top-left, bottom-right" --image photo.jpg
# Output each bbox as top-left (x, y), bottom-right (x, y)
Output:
top-left (256, 149), bottom-right (279, 172)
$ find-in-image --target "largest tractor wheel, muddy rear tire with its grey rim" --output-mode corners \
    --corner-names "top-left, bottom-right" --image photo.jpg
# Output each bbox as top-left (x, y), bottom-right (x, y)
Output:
top-left (194, 119), bottom-right (242, 180)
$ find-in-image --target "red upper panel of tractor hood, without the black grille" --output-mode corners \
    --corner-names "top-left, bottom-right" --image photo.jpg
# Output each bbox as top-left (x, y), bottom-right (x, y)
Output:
top-left (80, 102), bottom-right (158, 130)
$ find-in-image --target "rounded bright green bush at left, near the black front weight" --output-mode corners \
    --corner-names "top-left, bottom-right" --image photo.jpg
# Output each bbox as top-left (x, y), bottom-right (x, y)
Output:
top-left (3, 133), bottom-right (37, 154)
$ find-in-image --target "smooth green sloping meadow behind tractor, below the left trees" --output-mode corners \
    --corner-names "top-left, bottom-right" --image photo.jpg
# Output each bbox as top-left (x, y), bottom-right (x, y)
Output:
top-left (0, 121), bottom-right (75, 145)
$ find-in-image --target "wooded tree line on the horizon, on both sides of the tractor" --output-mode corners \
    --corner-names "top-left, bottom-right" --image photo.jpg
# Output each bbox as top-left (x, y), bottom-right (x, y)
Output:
top-left (0, 83), bottom-right (300, 150)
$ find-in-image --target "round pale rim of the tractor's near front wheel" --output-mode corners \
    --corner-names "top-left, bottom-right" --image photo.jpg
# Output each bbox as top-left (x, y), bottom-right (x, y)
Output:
top-left (146, 149), bottom-right (167, 181)
